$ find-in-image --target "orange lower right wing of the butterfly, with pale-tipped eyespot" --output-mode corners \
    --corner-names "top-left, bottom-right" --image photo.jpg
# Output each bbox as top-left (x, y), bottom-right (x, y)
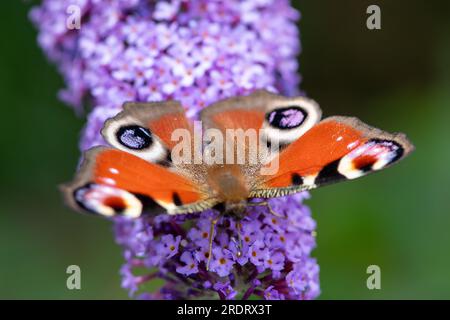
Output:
top-left (250, 116), bottom-right (414, 198)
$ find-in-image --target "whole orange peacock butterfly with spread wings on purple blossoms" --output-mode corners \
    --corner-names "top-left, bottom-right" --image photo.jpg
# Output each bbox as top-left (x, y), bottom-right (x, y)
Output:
top-left (63, 91), bottom-right (413, 218)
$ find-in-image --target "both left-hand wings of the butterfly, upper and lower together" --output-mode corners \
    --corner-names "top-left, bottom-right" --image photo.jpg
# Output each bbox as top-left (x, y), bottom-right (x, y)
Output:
top-left (64, 101), bottom-right (215, 217)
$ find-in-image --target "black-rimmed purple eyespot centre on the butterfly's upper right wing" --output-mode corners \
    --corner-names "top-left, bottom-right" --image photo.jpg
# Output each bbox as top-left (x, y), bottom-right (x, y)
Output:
top-left (266, 106), bottom-right (308, 130)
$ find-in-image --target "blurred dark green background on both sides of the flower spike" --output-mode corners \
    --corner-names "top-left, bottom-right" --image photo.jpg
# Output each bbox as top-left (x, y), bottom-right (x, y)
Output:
top-left (0, 0), bottom-right (450, 299)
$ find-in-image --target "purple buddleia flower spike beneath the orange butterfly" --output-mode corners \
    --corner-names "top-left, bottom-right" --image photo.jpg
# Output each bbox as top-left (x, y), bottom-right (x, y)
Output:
top-left (30, 0), bottom-right (320, 299)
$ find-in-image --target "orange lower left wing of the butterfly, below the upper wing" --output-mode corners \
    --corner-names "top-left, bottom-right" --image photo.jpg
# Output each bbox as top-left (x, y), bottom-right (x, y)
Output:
top-left (62, 147), bottom-right (215, 218)
